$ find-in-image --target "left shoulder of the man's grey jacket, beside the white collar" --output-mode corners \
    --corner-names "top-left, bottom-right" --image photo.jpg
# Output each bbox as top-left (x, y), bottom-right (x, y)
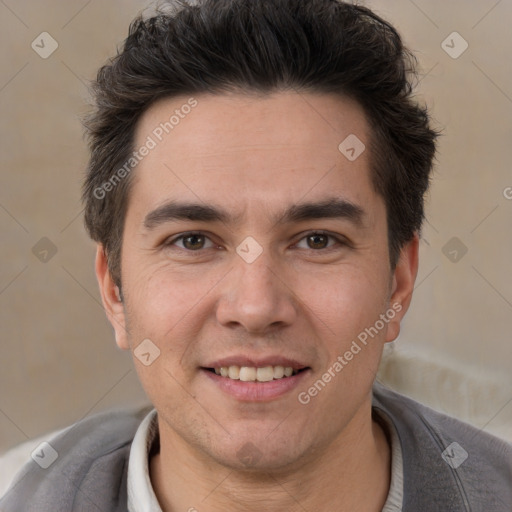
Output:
top-left (0, 406), bottom-right (152, 512)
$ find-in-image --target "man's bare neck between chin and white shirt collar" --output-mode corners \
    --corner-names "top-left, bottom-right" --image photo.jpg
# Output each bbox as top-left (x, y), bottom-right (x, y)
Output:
top-left (150, 404), bottom-right (391, 512)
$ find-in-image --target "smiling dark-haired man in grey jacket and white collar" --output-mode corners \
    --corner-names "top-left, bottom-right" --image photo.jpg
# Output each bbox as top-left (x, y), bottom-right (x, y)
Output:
top-left (0, 0), bottom-right (512, 512)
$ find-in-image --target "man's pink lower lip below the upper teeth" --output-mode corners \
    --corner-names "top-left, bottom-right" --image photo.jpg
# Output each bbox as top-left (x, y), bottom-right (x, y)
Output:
top-left (201, 368), bottom-right (310, 402)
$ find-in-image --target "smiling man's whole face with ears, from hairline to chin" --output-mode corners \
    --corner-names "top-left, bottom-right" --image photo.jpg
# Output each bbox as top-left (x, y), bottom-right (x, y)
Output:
top-left (97, 92), bottom-right (417, 469)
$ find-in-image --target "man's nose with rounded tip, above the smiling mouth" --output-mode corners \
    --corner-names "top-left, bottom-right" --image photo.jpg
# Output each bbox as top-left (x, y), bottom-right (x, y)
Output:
top-left (217, 251), bottom-right (297, 334)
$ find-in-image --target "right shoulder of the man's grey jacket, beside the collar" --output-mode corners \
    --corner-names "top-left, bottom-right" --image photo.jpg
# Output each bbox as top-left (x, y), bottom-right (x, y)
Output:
top-left (373, 383), bottom-right (512, 512)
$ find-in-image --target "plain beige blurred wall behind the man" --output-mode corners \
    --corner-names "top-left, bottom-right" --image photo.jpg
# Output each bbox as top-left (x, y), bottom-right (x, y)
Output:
top-left (0, 0), bottom-right (512, 452)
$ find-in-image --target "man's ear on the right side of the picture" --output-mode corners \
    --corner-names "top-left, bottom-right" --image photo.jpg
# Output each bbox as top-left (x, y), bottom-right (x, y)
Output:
top-left (386, 233), bottom-right (419, 341)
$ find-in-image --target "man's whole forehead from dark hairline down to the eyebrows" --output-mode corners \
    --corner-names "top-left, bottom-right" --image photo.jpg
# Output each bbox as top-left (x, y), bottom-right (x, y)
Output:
top-left (128, 92), bottom-right (372, 222)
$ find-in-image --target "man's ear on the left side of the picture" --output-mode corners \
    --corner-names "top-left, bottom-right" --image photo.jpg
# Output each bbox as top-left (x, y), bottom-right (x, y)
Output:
top-left (96, 244), bottom-right (130, 350)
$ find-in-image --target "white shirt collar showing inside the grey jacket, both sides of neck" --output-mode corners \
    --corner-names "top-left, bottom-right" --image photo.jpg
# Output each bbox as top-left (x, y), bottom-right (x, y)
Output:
top-left (128, 409), bottom-right (403, 512)
